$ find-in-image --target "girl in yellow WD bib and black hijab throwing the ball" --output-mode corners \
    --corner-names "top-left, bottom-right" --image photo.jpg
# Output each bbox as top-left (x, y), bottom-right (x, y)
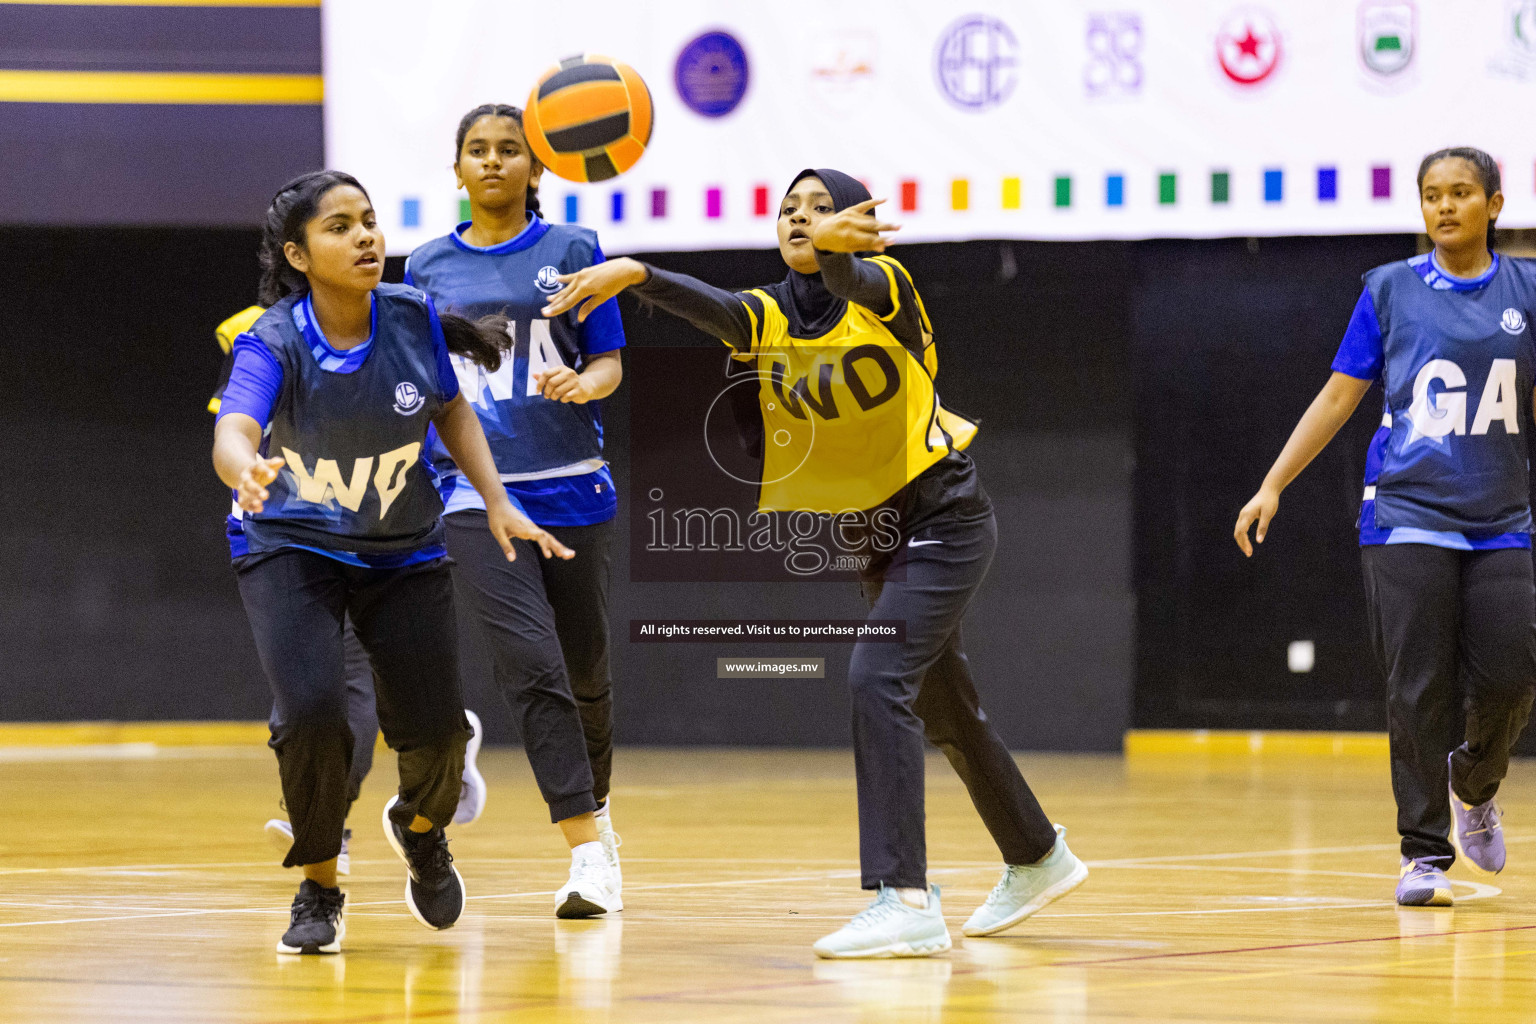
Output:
top-left (544, 167), bottom-right (1087, 958)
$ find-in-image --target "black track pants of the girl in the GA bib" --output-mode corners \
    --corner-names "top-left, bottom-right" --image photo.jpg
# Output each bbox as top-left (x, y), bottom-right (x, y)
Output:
top-left (1361, 543), bottom-right (1536, 864)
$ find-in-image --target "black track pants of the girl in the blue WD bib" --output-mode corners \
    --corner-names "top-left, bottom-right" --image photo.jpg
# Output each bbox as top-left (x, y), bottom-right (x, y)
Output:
top-left (235, 548), bottom-right (470, 867)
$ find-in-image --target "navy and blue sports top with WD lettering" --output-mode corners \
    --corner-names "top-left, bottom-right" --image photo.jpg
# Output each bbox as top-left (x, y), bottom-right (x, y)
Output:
top-left (218, 284), bottom-right (459, 568)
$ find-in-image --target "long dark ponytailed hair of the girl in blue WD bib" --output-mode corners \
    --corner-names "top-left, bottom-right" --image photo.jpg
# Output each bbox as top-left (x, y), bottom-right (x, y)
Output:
top-left (258, 170), bottom-right (511, 372)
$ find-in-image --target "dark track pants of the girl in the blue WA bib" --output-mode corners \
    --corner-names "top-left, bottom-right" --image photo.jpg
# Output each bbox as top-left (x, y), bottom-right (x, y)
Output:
top-left (444, 511), bottom-right (613, 821)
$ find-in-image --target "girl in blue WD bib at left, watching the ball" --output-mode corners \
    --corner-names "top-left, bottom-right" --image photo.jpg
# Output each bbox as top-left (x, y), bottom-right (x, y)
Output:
top-left (214, 170), bottom-right (571, 953)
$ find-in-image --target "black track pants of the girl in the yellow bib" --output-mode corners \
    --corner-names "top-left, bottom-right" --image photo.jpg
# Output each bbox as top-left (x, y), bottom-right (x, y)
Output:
top-left (848, 516), bottom-right (1055, 889)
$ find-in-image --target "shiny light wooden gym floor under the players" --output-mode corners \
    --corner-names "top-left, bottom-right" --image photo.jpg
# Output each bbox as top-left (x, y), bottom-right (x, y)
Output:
top-left (0, 745), bottom-right (1536, 1024)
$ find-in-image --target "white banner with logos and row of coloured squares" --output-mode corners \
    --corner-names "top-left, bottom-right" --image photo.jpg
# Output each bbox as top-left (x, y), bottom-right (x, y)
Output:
top-left (323, 0), bottom-right (1536, 253)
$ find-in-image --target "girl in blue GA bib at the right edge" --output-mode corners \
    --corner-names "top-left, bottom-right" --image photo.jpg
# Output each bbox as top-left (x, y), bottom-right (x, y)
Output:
top-left (1235, 147), bottom-right (1536, 906)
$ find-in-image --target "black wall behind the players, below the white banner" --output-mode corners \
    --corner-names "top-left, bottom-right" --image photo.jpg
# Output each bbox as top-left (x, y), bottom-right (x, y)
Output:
top-left (9, 229), bottom-right (1511, 749)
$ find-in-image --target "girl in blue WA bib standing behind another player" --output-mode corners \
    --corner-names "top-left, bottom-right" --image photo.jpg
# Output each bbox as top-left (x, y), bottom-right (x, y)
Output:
top-left (406, 104), bottom-right (624, 918)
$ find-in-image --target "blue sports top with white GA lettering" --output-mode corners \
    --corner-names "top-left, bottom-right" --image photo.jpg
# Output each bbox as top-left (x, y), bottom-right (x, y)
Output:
top-left (1333, 253), bottom-right (1536, 551)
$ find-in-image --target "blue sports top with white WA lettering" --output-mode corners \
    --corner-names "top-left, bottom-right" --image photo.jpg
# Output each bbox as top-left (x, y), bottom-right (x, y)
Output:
top-left (406, 213), bottom-right (624, 527)
